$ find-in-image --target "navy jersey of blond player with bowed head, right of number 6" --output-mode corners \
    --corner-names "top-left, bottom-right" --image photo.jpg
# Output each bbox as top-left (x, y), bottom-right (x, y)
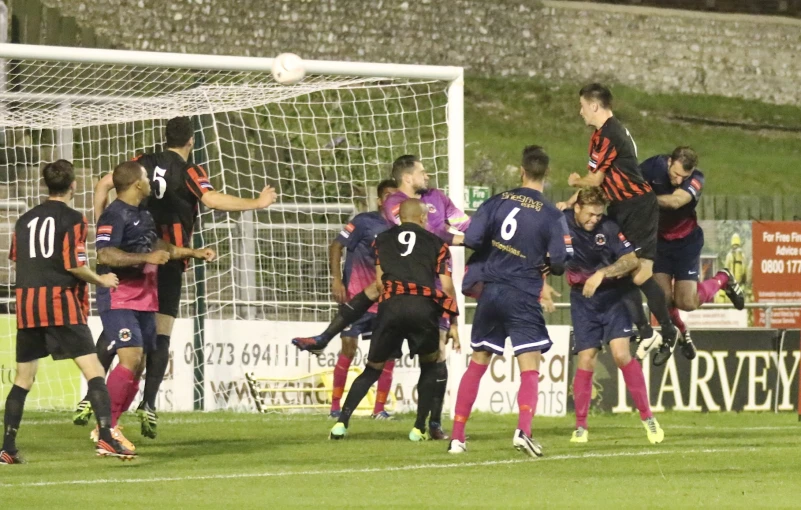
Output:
top-left (564, 209), bottom-right (634, 285)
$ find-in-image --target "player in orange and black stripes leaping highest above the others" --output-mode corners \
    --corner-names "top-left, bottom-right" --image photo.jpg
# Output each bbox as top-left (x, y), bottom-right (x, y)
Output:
top-left (557, 83), bottom-right (681, 365)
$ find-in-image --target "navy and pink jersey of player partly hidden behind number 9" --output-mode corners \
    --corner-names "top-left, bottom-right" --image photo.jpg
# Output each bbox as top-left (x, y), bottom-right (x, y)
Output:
top-left (336, 211), bottom-right (389, 302)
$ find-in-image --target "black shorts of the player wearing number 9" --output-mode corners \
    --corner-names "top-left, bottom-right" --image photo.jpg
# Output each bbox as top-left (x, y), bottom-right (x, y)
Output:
top-left (367, 295), bottom-right (442, 363)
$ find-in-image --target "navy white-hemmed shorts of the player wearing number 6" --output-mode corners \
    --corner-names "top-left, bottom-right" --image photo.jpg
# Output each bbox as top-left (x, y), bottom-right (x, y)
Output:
top-left (470, 283), bottom-right (553, 356)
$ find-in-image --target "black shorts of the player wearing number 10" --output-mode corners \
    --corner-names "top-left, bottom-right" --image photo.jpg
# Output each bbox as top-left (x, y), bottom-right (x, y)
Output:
top-left (17, 324), bottom-right (96, 363)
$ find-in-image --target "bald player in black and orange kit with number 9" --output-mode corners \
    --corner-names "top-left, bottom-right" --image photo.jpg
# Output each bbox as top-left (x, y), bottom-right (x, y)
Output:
top-left (329, 198), bottom-right (458, 441)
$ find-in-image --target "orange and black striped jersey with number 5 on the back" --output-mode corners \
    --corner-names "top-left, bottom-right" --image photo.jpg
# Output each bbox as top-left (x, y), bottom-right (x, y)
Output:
top-left (136, 150), bottom-right (214, 246)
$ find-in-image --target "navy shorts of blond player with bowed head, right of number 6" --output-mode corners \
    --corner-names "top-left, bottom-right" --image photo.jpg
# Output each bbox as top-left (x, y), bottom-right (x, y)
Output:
top-left (570, 286), bottom-right (633, 354)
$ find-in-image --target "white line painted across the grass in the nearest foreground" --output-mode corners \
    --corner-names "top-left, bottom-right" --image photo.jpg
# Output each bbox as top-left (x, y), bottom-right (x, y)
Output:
top-left (0, 448), bottom-right (756, 488)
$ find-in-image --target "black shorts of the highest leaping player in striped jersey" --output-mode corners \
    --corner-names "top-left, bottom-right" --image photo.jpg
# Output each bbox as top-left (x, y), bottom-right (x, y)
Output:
top-left (609, 191), bottom-right (659, 260)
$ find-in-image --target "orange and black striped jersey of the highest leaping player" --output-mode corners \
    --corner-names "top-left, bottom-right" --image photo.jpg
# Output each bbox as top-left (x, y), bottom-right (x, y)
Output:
top-left (587, 117), bottom-right (651, 202)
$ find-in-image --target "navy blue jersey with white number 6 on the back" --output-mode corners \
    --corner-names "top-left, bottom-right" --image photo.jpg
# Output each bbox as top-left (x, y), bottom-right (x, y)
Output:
top-left (464, 188), bottom-right (573, 297)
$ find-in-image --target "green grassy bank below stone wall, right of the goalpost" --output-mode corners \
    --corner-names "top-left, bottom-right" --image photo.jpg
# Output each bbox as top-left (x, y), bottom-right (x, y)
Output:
top-left (465, 77), bottom-right (801, 195)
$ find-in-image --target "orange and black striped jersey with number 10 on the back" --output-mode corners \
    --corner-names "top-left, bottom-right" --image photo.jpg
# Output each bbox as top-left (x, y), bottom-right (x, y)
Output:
top-left (9, 200), bottom-right (89, 329)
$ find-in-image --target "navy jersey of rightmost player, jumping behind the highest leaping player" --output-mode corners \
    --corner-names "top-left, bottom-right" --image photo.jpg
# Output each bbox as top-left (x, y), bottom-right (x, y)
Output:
top-left (640, 154), bottom-right (704, 241)
